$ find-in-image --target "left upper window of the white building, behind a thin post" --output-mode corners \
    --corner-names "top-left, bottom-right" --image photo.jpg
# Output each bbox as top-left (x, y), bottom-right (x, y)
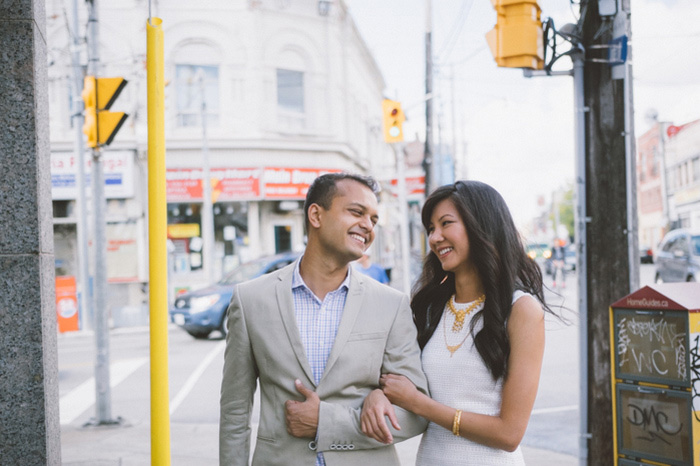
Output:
top-left (175, 65), bottom-right (219, 126)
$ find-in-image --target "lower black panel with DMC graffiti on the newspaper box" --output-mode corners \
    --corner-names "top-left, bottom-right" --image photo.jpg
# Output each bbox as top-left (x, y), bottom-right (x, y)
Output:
top-left (617, 384), bottom-right (693, 466)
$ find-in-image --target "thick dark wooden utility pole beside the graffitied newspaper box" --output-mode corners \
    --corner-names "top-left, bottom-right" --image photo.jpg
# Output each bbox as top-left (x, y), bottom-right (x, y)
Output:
top-left (581, 0), bottom-right (639, 465)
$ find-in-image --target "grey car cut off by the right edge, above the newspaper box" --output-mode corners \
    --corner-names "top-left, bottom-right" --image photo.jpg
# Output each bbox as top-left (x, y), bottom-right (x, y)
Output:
top-left (655, 229), bottom-right (700, 283)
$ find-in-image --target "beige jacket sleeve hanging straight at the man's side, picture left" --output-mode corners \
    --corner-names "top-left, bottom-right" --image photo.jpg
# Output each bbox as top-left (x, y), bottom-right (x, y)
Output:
top-left (219, 286), bottom-right (258, 466)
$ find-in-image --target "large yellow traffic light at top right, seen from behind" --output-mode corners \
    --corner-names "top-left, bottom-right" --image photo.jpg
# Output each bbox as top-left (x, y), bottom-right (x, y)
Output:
top-left (486, 0), bottom-right (544, 70)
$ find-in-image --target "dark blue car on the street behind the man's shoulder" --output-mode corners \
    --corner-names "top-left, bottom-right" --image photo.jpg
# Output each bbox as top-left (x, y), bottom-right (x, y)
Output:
top-left (169, 252), bottom-right (301, 338)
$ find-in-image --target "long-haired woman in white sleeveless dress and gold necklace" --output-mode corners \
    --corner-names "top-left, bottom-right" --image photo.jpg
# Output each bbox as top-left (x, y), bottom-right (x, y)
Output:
top-left (362, 181), bottom-right (550, 466)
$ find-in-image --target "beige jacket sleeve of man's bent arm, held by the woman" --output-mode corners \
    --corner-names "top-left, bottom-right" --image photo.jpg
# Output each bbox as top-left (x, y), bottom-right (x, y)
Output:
top-left (317, 296), bottom-right (428, 451)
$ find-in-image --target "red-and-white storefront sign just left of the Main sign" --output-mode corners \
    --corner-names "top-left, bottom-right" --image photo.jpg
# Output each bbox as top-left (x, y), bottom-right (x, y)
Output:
top-left (165, 168), bottom-right (261, 202)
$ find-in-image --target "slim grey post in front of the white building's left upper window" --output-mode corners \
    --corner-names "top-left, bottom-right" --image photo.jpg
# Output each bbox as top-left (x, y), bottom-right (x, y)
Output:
top-left (197, 69), bottom-right (214, 283)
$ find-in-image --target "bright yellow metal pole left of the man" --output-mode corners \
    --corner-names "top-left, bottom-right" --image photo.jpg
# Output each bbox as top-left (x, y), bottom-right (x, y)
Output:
top-left (146, 18), bottom-right (170, 466)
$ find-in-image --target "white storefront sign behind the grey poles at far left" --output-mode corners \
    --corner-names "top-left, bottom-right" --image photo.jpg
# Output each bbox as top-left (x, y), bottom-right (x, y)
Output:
top-left (51, 151), bottom-right (134, 200)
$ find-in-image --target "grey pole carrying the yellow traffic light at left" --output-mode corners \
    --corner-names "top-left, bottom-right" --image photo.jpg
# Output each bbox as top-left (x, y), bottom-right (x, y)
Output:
top-left (87, 0), bottom-right (119, 425)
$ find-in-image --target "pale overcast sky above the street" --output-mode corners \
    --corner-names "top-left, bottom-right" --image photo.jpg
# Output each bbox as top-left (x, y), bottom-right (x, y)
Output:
top-left (345, 0), bottom-right (700, 232)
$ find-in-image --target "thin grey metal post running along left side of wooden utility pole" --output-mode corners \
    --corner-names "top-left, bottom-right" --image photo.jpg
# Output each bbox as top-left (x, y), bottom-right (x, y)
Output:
top-left (572, 52), bottom-right (590, 466)
